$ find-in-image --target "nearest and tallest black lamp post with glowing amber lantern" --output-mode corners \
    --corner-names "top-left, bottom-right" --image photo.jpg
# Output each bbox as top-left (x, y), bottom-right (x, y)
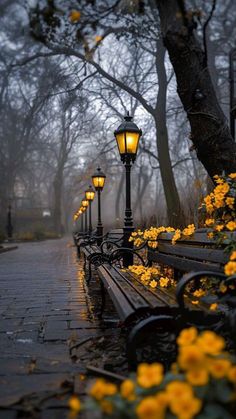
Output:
top-left (114, 113), bottom-right (142, 267)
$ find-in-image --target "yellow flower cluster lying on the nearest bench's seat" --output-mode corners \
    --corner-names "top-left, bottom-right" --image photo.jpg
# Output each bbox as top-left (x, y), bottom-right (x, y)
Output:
top-left (129, 265), bottom-right (172, 288)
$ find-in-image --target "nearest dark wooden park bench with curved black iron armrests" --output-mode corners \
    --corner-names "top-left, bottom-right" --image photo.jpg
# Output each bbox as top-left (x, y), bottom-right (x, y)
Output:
top-left (87, 230), bottom-right (235, 367)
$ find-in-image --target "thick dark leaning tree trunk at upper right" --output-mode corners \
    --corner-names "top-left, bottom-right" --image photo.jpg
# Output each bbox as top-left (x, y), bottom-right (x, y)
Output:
top-left (156, 0), bottom-right (236, 177)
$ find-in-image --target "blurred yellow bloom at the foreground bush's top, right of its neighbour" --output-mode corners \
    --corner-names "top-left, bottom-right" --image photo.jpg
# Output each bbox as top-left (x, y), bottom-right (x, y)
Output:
top-left (197, 330), bottom-right (225, 355)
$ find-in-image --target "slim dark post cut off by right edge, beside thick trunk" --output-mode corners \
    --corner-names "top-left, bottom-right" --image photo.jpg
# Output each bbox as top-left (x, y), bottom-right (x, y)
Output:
top-left (229, 48), bottom-right (236, 140)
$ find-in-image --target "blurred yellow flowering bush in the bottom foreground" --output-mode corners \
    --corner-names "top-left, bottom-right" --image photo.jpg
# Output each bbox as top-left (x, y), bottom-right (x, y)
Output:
top-left (69, 327), bottom-right (236, 419)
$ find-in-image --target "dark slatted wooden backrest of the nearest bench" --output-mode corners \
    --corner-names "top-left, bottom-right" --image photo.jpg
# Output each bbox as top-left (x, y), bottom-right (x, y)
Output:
top-left (148, 229), bottom-right (236, 272)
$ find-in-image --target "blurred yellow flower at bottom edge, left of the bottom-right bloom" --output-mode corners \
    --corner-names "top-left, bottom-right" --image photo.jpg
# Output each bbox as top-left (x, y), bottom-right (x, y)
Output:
top-left (136, 396), bottom-right (164, 419)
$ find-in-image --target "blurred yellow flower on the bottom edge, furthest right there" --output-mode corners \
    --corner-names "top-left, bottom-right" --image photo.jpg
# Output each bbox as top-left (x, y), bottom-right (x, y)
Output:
top-left (170, 397), bottom-right (202, 419)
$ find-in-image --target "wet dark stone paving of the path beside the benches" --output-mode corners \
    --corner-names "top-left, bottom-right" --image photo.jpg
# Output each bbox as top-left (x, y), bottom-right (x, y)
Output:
top-left (0, 239), bottom-right (124, 419)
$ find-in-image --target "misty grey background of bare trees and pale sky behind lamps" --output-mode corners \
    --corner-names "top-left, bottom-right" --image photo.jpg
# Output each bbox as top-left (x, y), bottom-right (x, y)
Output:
top-left (0, 0), bottom-right (236, 239)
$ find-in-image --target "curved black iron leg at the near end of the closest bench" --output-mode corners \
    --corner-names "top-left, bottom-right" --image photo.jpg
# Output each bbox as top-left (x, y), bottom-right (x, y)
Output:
top-left (126, 315), bottom-right (174, 370)
